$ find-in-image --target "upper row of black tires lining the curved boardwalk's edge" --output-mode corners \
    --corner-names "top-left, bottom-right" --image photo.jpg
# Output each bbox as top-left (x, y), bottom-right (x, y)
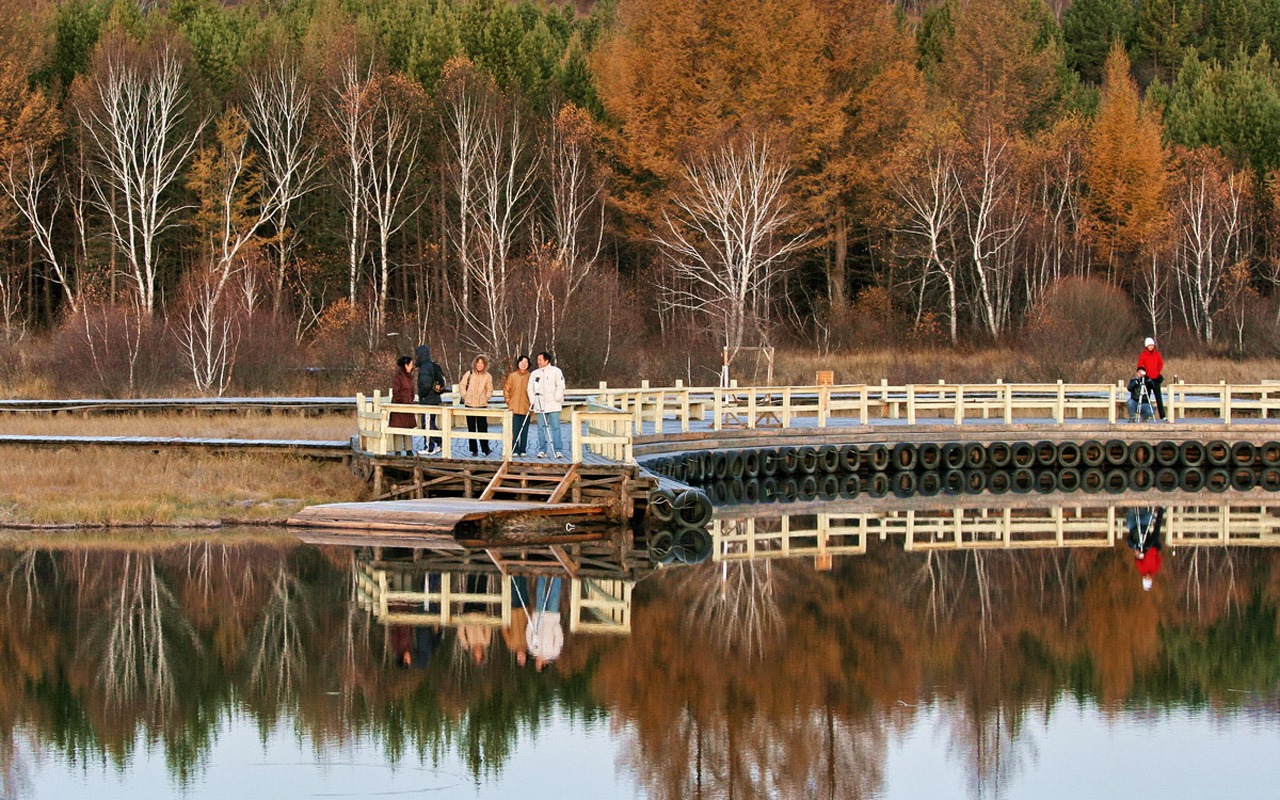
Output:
top-left (645, 439), bottom-right (1280, 484)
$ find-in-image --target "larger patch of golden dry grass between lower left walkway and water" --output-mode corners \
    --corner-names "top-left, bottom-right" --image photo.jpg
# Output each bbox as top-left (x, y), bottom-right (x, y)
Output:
top-left (0, 448), bottom-right (365, 526)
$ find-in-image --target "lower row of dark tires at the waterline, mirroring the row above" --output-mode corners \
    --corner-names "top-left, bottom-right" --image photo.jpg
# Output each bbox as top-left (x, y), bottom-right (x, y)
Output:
top-left (707, 467), bottom-right (1280, 506)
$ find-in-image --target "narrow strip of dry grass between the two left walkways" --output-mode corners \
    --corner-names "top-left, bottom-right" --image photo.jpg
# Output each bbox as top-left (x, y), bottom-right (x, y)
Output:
top-left (0, 412), bottom-right (356, 439)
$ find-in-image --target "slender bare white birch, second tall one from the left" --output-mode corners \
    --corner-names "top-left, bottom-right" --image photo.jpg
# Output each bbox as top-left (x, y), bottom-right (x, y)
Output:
top-left (244, 56), bottom-right (321, 314)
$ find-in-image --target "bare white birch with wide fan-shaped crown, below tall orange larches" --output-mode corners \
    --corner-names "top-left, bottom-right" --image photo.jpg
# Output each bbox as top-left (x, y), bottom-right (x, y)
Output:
top-left (655, 133), bottom-right (806, 360)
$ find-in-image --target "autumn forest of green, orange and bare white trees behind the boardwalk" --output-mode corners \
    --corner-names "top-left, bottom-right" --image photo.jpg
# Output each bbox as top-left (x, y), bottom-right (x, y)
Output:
top-left (0, 0), bottom-right (1280, 396)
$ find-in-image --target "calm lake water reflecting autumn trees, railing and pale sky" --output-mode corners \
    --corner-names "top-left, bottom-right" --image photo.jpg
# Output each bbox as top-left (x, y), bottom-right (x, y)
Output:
top-left (0, 498), bottom-right (1280, 799)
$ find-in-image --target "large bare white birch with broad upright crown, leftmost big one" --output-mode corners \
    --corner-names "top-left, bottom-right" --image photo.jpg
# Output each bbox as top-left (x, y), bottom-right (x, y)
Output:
top-left (76, 44), bottom-right (204, 316)
